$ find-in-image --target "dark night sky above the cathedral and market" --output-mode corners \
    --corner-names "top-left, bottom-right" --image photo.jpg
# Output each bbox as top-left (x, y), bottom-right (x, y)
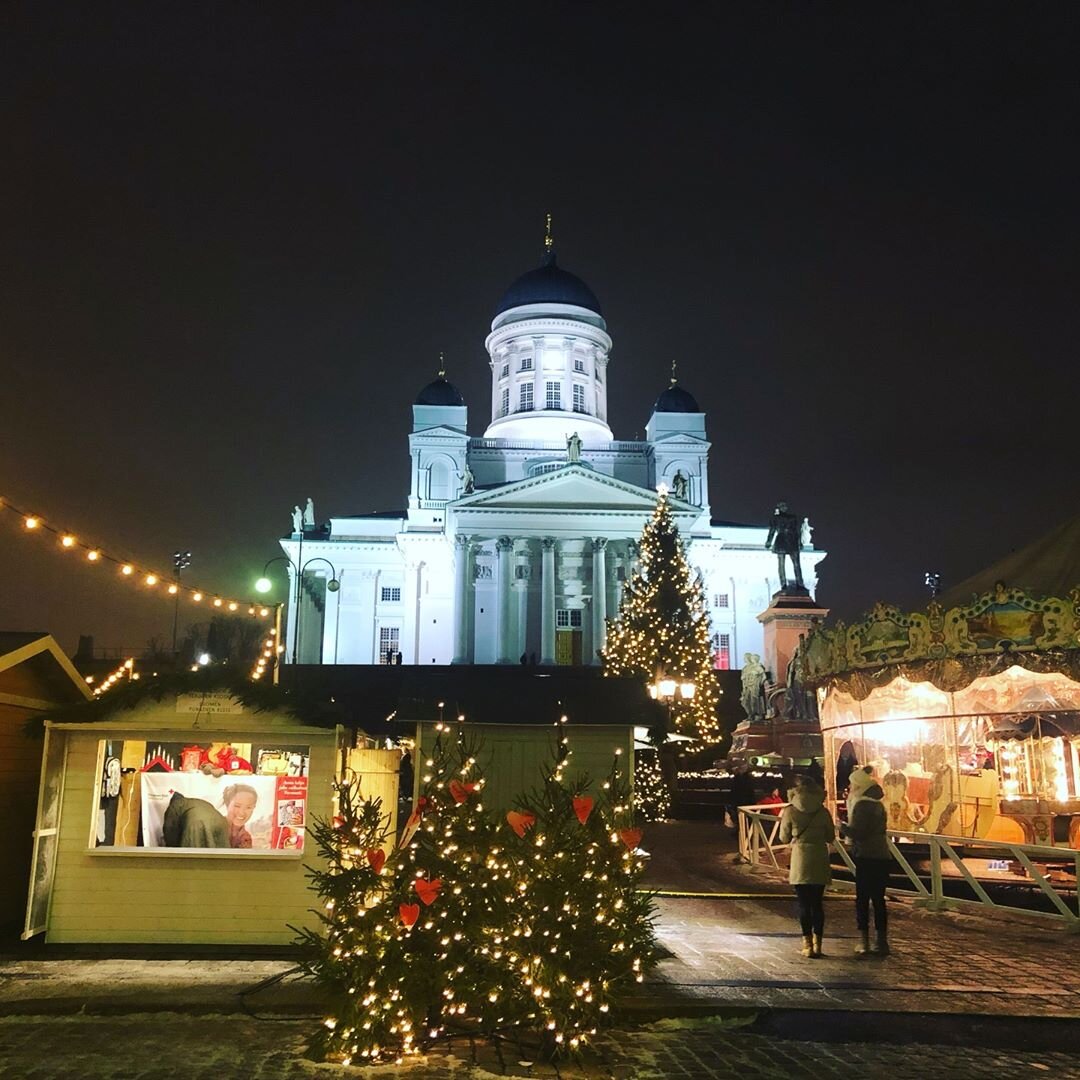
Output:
top-left (0, 2), bottom-right (1080, 650)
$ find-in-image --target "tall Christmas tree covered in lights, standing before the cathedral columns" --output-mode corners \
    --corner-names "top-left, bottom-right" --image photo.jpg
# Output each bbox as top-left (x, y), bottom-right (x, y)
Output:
top-left (602, 489), bottom-right (720, 742)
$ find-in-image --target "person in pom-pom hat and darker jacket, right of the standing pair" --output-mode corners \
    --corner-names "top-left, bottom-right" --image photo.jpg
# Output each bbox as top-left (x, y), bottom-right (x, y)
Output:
top-left (840, 766), bottom-right (892, 956)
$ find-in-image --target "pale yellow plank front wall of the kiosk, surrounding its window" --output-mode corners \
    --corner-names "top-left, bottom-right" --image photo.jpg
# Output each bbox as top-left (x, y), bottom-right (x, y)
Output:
top-left (46, 729), bottom-right (335, 945)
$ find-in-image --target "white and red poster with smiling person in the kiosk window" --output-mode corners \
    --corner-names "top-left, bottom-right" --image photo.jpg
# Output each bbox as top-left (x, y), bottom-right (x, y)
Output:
top-left (141, 772), bottom-right (308, 854)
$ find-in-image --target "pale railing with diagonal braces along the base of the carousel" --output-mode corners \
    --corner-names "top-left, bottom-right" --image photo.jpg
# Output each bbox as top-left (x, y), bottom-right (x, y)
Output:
top-left (739, 804), bottom-right (1080, 933)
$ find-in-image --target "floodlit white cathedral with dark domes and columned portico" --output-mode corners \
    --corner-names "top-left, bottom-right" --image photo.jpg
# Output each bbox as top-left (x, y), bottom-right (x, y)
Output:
top-left (281, 240), bottom-right (825, 667)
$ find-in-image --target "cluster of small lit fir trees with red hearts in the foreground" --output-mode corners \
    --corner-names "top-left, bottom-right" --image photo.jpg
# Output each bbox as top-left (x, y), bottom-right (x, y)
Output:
top-left (301, 725), bottom-right (653, 1064)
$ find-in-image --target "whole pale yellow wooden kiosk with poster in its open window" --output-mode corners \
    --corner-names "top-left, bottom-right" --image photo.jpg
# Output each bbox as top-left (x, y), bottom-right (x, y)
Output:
top-left (24, 691), bottom-right (347, 944)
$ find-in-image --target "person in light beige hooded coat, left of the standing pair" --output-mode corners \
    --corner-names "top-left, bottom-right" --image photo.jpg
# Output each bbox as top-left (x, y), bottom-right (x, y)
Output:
top-left (780, 777), bottom-right (836, 957)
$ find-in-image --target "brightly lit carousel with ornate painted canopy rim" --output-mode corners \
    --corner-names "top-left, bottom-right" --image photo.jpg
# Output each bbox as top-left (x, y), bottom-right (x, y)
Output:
top-left (795, 519), bottom-right (1080, 848)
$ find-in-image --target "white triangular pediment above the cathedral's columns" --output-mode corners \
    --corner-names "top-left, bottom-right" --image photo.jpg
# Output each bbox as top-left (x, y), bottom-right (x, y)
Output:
top-left (450, 464), bottom-right (701, 515)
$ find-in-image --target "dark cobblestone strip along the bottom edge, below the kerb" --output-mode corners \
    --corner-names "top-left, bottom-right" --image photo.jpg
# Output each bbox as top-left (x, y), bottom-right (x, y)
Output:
top-left (0, 1013), bottom-right (1080, 1080)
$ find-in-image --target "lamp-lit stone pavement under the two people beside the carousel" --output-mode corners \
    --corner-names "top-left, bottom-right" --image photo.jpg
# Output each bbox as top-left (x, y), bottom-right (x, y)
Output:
top-left (647, 822), bottom-right (1080, 1016)
